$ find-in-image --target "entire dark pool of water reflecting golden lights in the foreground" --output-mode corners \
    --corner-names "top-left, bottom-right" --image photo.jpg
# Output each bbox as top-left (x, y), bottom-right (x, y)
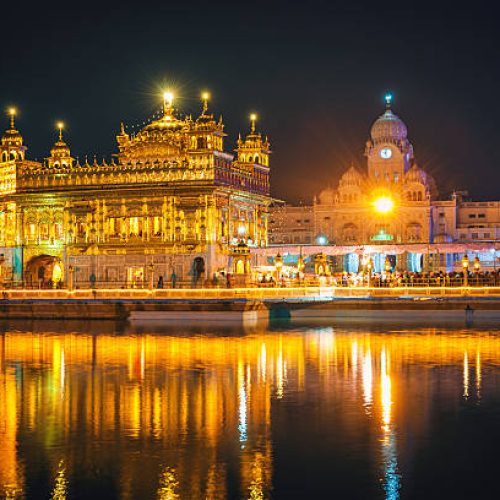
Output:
top-left (0, 322), bottom-right (500, 500)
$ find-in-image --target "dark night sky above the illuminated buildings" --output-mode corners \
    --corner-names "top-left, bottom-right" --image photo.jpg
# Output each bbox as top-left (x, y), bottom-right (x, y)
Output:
top-left (0, 0), bottom-right (500, 201)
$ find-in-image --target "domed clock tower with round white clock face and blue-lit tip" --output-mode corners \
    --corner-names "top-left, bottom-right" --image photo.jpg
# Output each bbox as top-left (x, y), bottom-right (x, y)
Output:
top-left (365, 94), bottom-right (413, 184)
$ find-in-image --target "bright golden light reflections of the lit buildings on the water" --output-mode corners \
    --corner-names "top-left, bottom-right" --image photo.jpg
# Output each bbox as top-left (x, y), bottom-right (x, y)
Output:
top-left (0, 328), bottom-right (500, 498)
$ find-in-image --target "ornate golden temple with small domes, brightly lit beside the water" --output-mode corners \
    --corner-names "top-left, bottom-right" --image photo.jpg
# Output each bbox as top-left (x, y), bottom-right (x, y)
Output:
top-left (0, 94), bottom-right (270, 286)
